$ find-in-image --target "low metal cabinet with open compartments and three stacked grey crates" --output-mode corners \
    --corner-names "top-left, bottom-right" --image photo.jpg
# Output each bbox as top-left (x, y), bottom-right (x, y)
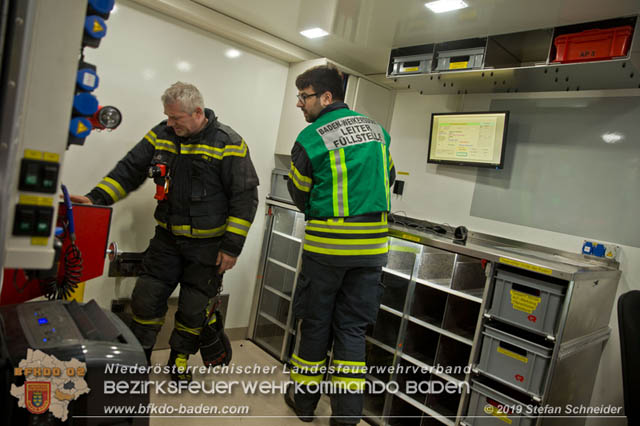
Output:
top-left (250, 201), bottom-right (620, 426)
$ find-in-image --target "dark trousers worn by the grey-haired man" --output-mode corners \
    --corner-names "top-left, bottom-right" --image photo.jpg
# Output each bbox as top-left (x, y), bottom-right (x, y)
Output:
top-left (131, 227), bottom-right (222, 354)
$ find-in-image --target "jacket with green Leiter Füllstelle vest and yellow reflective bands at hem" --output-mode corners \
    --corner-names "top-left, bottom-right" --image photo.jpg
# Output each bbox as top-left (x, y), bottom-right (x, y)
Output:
top-left (288, 102), bottom-right (395, 262)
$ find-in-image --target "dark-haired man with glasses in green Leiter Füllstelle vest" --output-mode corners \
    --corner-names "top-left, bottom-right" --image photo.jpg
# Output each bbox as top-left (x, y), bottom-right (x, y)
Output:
top-left (285, 66), bottom-right (395, 425)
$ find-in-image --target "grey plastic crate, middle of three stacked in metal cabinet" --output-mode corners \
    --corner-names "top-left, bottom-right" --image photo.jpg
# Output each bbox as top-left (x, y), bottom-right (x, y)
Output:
top-left (478, 326), bottom-right (552, 396)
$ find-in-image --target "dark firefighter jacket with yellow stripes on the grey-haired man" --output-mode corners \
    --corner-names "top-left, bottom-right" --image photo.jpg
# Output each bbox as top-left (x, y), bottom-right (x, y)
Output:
top-left (87, 109), bottom-right (259, 256)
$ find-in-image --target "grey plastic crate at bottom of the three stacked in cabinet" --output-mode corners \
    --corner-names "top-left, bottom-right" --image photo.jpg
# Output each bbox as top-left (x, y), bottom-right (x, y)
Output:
top-left (464, 381), bottom-right (537, 426)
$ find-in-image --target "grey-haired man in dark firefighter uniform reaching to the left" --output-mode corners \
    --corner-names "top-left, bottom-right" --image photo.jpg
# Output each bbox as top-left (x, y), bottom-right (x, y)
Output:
top-left (75, 82), bottom-right (258, 380)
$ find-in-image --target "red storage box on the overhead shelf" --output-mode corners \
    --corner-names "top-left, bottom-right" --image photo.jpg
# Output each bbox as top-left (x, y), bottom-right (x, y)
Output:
top-left (553, 25), bottom-right (633, 63)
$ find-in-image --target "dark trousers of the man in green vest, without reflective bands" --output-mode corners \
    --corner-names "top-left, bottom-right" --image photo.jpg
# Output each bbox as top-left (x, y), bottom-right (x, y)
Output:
top-left (293, 253), bottom-right (383, 424)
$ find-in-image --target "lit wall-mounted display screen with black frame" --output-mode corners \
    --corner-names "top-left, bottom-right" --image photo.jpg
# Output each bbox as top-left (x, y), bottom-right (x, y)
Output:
top-left (427, 111), bottom-right (509, 169)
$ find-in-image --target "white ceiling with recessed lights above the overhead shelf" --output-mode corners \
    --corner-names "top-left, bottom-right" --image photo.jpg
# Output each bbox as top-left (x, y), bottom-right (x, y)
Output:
top-left (192, 0), bottom-right (640, 74)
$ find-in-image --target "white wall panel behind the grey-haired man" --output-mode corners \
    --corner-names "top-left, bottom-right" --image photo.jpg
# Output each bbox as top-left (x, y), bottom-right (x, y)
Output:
top-left (63, 1), bottom-right (288, 328)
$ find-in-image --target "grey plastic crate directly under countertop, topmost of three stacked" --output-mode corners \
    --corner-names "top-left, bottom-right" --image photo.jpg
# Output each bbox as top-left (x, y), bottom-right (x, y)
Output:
top-left (488, 271), bottom-right (565, 336)
